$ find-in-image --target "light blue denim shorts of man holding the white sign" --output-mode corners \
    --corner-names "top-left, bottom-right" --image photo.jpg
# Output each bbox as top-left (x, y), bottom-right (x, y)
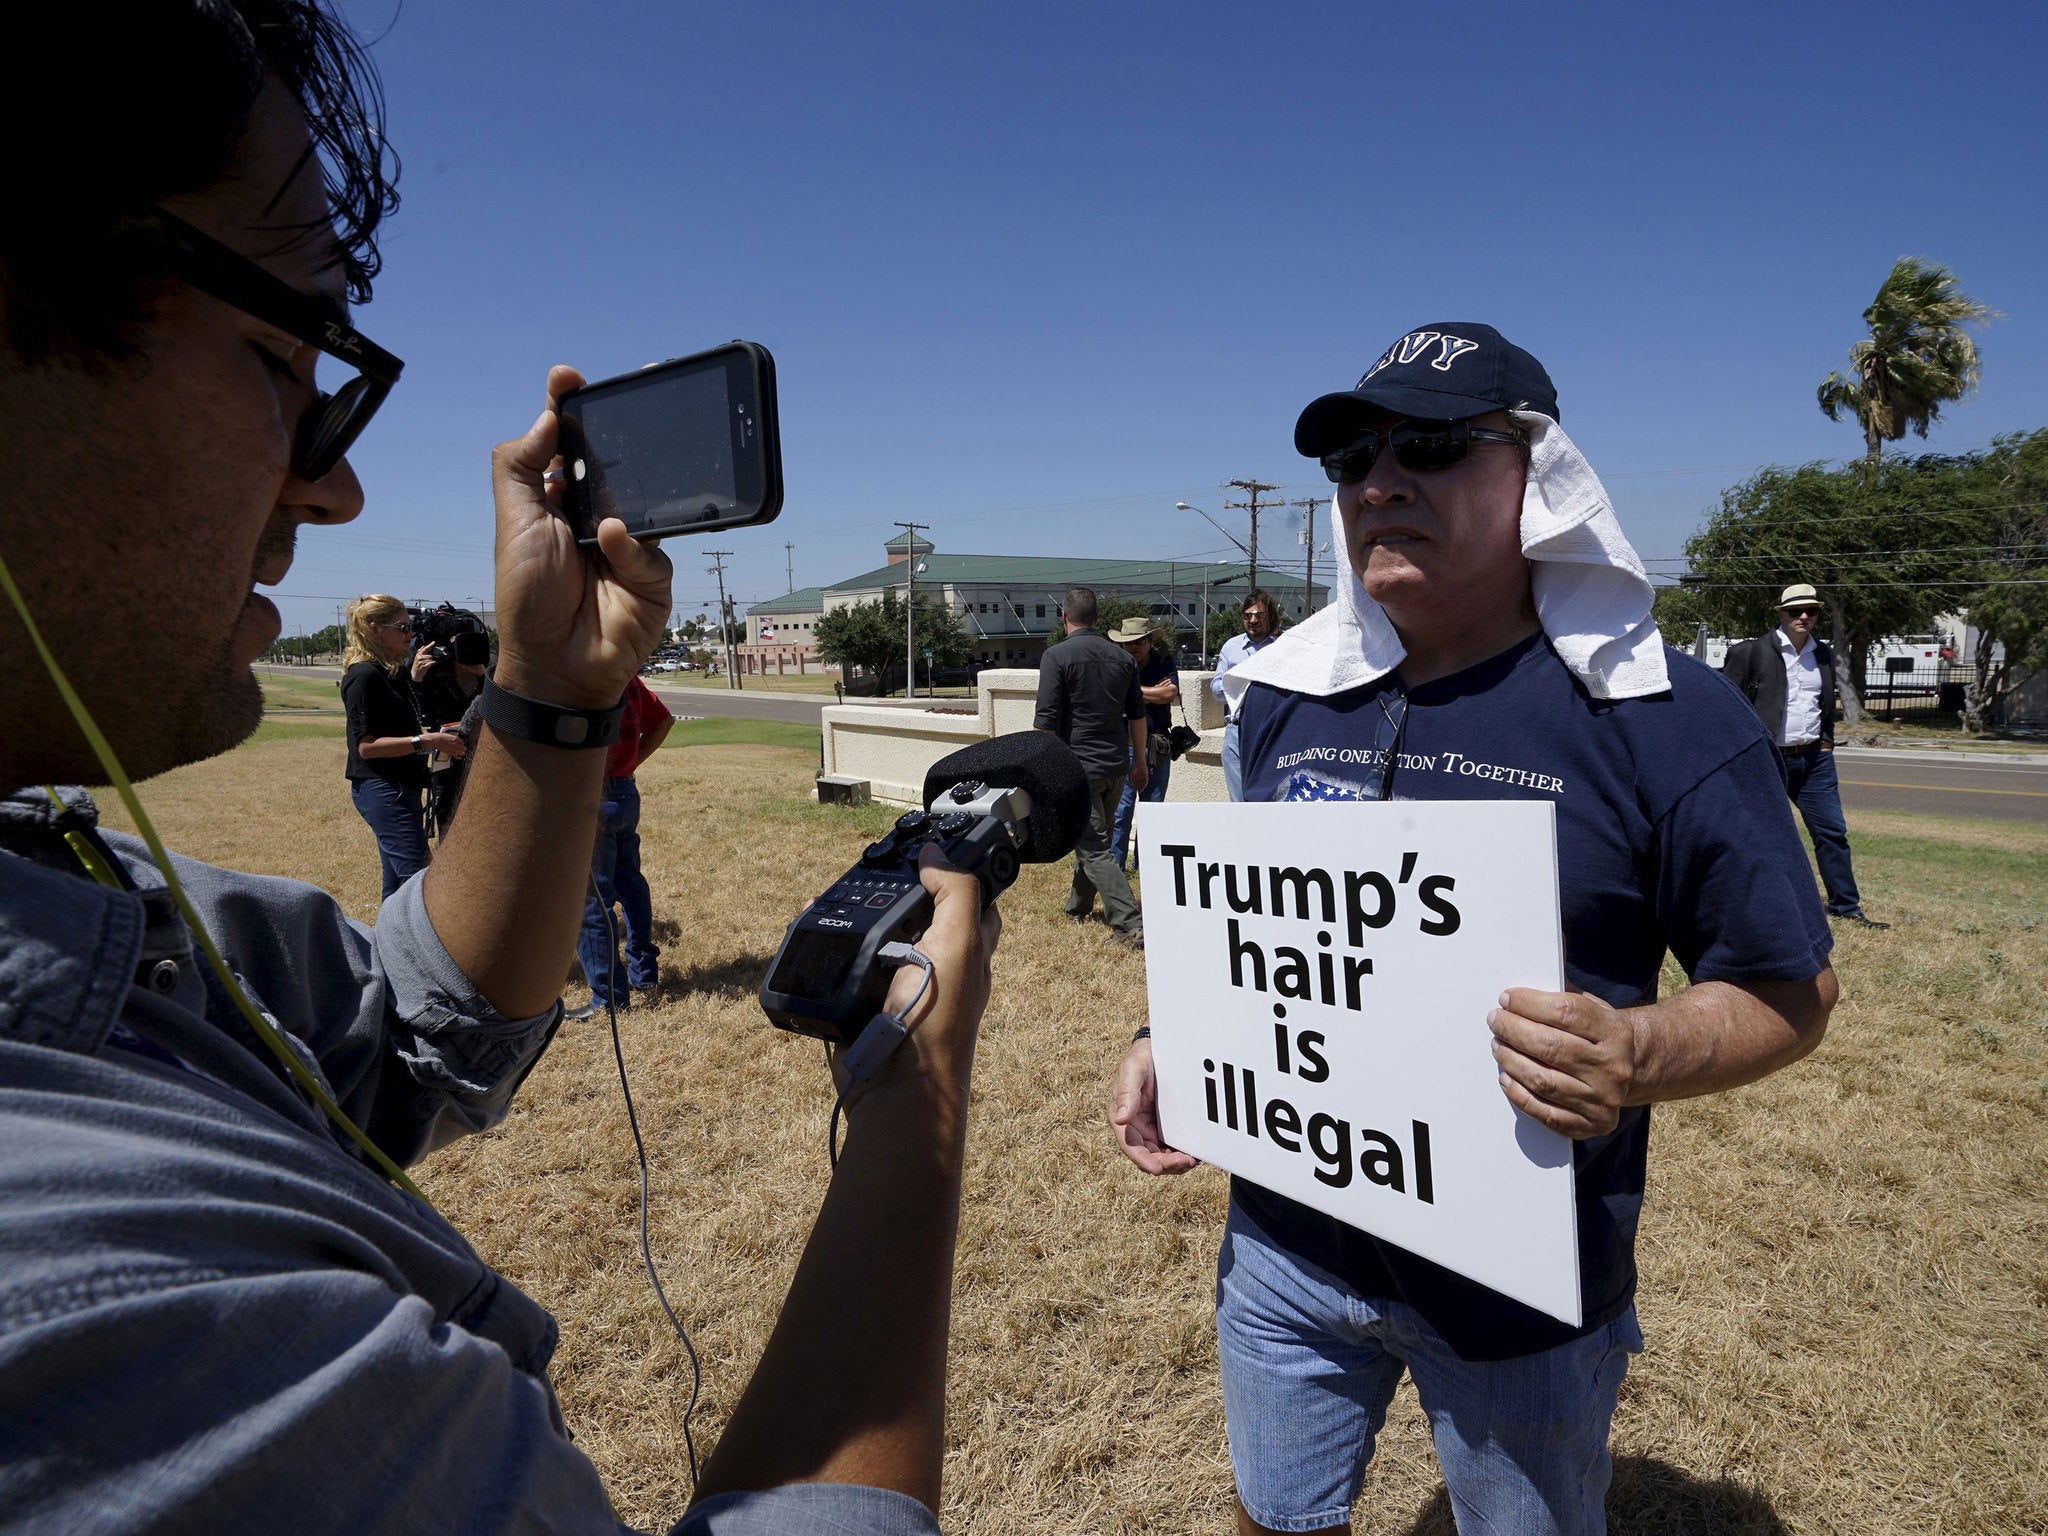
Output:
top-left (1217, 1202), bottom-right (1642, 1536)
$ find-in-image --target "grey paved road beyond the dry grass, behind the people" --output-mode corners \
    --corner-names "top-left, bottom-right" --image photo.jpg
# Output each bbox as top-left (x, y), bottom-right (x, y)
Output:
top-left (264, 668), bottom-right (2048, 821)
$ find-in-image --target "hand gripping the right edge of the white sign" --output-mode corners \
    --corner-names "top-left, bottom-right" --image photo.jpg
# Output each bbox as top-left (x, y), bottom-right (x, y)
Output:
top-left (1487, 987), bottom-right (1636, 1141)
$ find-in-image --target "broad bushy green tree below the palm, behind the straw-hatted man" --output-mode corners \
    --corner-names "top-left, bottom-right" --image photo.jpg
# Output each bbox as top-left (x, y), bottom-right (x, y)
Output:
top-left (1669, 457), bottom-right (1997, 725)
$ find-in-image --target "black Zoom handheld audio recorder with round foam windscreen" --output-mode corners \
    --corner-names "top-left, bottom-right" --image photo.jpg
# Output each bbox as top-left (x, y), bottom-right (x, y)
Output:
top-left (760, 731), bottom-right (1087, 1047)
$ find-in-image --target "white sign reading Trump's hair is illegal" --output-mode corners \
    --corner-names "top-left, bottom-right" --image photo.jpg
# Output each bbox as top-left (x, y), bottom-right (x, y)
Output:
top-left (1137, 801), bottom-right (1581, 1325)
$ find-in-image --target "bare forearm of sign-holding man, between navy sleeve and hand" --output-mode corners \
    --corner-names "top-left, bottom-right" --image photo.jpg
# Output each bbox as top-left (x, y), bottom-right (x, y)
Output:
top-left (1624, 969), bottom-right (1839, 1104)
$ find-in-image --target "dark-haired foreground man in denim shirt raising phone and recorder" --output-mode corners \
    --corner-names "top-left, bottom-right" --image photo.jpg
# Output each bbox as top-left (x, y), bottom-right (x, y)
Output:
top-left (0, 0), bottom-right (995, 1536)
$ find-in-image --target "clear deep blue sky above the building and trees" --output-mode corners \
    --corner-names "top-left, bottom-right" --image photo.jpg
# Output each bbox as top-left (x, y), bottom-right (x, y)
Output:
top-left (281, 0), bottom-right (2048, 629)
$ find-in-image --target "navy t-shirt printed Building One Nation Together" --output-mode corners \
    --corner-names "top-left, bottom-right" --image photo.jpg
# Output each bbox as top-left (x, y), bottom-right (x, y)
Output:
top-left (1233, 635), bottom-right (1833, 1360)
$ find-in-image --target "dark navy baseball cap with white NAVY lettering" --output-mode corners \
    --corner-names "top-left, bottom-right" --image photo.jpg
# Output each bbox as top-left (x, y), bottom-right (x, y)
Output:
top-left (1294, 319), bottom-right (1559, 459)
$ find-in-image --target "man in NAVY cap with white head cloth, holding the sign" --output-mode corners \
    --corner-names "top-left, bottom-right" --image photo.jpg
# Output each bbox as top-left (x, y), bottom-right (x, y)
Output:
top-left (1110, 322), bottom-right (1835, 1536)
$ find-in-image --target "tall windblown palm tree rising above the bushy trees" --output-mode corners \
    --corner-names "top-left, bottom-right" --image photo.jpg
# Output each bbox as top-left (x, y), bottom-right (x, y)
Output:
top-left (1819, 256), bottom-right (1997, 463)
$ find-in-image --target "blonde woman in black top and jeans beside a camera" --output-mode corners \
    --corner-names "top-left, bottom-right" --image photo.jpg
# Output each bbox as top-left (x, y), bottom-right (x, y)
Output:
top-left (342, 592), bottom-right (465, 901)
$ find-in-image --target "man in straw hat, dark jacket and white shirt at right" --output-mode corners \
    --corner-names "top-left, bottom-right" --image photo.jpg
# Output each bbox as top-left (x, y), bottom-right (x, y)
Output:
top-left (1720, 582), bottom-right (1890, 928)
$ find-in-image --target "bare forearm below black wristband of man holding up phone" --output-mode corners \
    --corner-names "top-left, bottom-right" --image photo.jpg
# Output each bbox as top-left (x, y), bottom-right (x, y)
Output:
top-left (424, 725), bottom-right (604, 1018)
